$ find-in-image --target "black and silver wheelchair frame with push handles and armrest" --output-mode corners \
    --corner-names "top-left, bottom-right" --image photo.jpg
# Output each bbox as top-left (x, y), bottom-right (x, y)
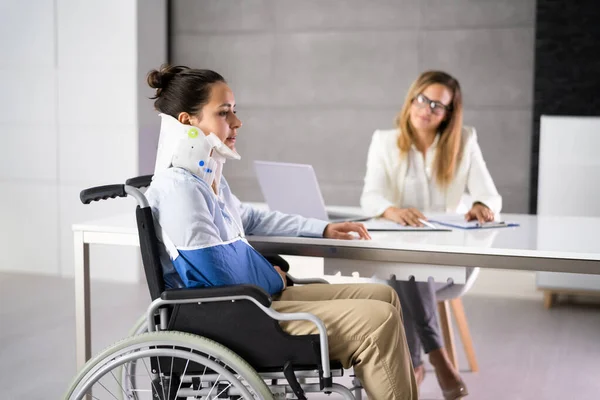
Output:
top-left (67, 175), bottom-right (362, 400)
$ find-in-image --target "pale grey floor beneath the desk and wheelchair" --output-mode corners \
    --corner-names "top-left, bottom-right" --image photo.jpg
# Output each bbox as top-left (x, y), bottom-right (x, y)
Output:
top-left (0, 273), bottom-right (600, 400)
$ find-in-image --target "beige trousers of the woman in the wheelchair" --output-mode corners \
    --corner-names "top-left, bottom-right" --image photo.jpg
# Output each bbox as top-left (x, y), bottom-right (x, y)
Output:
top-left (273, 284), bottom-right (418, 400)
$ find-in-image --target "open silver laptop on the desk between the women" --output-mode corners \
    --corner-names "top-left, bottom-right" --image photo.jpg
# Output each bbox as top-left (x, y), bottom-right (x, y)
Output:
top-left (254, 161), bottom-right (369, 222)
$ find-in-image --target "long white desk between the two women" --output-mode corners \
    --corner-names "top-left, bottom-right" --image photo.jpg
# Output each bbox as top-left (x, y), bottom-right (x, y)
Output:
top-left (73, 209), bottom-right (600, 368)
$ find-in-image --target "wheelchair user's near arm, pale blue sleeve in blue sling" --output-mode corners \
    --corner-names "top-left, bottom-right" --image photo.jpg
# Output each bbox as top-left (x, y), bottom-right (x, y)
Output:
top-left (156, 181), bottom-right (284, 294)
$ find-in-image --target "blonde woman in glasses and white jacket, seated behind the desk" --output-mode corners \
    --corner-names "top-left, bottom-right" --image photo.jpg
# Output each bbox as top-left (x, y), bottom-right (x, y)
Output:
top-left (361, 71), bottom-right (502, 399)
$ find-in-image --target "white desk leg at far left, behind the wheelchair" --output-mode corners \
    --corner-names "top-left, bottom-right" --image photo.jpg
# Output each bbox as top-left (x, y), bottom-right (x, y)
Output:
top-left (74, 232), bottom-right (92, 370)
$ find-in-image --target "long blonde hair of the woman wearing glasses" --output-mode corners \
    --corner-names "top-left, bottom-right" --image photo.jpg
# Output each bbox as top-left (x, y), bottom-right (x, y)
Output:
top-left (395, 71), bottom-right (463, 186)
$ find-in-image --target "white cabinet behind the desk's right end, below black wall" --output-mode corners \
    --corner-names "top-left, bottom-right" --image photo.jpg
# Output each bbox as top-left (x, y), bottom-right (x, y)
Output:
top-left (537, 115), bottom-right (600, 291)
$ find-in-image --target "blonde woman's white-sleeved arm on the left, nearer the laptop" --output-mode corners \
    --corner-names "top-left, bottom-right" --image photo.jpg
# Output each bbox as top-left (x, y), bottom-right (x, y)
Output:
top-left (360, 131), bottom-right (394, 216)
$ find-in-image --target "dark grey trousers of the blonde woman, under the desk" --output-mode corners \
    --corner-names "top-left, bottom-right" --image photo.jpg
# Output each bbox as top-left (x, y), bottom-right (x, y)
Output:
top-left (390, 278), bottom-right (444, 368)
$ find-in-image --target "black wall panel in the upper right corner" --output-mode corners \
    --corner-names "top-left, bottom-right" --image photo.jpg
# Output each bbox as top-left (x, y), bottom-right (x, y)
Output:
top-left (530, 0), bottom-right (600, 213)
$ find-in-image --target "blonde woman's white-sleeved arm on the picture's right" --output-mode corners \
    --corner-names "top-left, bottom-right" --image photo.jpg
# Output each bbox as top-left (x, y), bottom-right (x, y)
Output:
top-left (467, 129), bottom-right (502, 214)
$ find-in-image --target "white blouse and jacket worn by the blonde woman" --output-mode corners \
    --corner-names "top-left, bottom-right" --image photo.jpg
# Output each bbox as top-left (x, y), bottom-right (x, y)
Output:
top-left (360, 126), bottom-right (502, 216)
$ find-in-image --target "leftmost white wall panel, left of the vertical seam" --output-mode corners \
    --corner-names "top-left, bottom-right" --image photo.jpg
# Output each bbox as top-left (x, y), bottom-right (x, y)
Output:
top-left (0, 0), bottom-right (60, 274)
